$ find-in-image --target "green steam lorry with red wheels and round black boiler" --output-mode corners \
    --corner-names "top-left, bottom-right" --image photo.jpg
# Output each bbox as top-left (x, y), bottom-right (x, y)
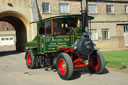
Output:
top-left (25, 13), bottom-right (105, 80)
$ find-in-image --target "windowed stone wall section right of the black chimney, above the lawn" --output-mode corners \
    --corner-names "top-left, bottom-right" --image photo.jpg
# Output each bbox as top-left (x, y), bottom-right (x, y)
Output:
top-left (89, 0), bottom-right (128, 49)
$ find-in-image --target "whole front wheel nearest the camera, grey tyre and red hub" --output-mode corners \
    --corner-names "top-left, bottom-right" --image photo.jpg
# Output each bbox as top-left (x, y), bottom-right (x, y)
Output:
top-left (56, 53), bottom-right (73, 80)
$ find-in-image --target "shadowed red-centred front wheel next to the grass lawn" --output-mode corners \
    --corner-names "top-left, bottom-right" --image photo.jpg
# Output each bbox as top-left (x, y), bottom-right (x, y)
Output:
top-left (89, 51), bottom-right (105, 74)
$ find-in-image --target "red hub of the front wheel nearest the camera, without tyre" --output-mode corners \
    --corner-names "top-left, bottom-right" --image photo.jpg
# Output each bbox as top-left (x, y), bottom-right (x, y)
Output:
top-left (58, 58), bottom-right (67, 75)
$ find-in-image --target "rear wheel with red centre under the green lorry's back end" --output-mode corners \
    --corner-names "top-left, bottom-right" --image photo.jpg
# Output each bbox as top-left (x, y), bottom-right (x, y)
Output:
top-left (26, 50), bottom-right (36, 69)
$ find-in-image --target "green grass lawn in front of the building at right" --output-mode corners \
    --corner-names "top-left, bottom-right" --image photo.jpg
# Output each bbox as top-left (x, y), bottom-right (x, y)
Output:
top-left (102, 50), bottom-right (128, 69)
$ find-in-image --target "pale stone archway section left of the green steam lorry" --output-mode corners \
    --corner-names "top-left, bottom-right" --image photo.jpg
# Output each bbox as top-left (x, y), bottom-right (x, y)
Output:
top-left (0, 0), bottom-right (33, 51)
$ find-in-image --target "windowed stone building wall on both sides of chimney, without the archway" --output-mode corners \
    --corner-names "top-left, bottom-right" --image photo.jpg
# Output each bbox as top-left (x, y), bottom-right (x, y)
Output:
top-left (38, 0), bottom-right (128, 49)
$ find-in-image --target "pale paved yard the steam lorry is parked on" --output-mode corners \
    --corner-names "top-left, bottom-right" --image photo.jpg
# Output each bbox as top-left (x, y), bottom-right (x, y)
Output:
top-left (0, 46), bottom-right (128, 85)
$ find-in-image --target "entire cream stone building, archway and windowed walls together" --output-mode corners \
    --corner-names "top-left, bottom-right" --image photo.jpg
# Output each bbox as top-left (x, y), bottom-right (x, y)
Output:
top-left (0, 0), bottom-right (128, 50)
